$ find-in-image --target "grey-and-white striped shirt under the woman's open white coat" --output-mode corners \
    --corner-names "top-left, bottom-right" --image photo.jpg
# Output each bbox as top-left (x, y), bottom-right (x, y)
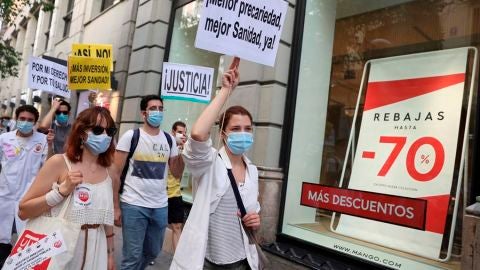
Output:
top-left (205, 186), bottom-right (247, 264)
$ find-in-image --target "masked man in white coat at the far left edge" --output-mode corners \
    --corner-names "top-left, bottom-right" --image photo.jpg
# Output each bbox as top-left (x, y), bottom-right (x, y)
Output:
top-left (0, 105), bottom-right (48, 266)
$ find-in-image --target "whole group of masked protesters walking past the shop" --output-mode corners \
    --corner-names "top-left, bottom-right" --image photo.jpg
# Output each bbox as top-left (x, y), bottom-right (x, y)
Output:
top-left (0, 58), bottom-right (261, 270)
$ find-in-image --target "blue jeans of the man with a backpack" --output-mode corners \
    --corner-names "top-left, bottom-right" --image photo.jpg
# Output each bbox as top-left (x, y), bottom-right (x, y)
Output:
top-left (120, 202), bottom-right (168, 270)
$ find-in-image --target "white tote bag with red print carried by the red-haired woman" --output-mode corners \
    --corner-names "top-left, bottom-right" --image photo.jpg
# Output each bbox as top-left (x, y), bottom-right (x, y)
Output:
top-left (3, 155), bottom-right (81, 270)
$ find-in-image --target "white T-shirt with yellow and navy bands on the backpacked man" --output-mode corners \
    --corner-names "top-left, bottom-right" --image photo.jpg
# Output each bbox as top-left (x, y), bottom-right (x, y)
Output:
top-left (117, 129), bottom-right (178, 208)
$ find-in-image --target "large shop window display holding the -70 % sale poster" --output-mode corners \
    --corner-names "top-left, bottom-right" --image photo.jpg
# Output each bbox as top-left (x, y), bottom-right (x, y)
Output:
top-left (281, 0), bottom-right (479, 269)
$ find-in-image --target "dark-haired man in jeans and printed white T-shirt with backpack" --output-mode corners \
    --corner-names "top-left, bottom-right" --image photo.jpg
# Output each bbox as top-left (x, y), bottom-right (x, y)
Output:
top-left (114, 95), bottom-right (184, 270)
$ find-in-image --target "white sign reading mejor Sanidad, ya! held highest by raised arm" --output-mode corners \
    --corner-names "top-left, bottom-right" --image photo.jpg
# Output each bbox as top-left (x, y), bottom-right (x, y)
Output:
top-left (195, 0), bottom-right (288, 66)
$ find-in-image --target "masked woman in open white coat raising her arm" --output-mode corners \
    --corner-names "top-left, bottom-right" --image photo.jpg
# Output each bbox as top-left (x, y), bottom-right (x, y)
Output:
top-left (170, 58), bottom-right (260, 269)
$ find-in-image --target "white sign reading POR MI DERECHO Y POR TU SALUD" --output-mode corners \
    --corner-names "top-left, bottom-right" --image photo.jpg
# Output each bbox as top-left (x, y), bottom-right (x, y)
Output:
top-left (28, 57), bottom-right (71, 98)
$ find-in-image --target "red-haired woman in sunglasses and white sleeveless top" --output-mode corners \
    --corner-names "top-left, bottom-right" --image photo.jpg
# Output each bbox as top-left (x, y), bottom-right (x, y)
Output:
top-left (19, 107), bottom-right (116, 269)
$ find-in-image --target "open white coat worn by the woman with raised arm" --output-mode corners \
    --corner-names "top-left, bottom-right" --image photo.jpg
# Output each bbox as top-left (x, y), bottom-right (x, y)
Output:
top-left (170, 138), bottom-right (260, 270)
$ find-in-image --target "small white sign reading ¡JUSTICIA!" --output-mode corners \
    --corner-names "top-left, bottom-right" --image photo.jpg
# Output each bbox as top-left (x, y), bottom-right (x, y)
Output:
top-left (161, 62), bottom-right (214, 103)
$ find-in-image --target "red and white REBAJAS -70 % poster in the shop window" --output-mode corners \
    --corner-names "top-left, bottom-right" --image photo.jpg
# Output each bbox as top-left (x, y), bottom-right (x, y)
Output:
top-left (335, 48), bottom-right (468, 258)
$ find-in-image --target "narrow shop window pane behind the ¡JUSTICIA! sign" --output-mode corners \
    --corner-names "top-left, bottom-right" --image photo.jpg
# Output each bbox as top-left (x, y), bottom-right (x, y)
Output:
top-left (163, 1), bottom-right (221, 202)
